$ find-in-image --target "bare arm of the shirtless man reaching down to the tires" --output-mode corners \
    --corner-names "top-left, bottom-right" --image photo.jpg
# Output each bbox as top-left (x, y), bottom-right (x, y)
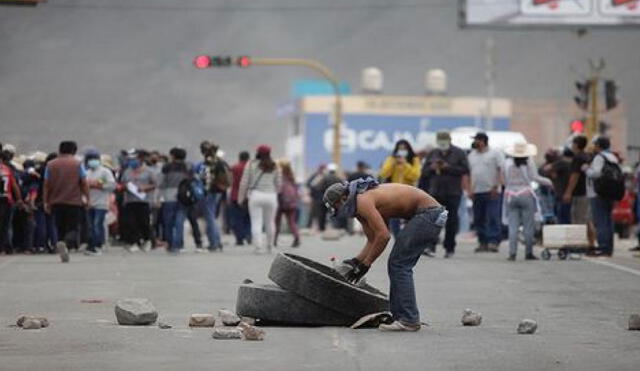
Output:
top-left (358, 196), bottom-right (391, 266)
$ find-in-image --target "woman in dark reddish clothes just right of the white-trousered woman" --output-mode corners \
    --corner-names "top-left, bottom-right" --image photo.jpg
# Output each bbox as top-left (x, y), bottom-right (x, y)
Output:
top-left (273, 159), bottom-right (300, 247)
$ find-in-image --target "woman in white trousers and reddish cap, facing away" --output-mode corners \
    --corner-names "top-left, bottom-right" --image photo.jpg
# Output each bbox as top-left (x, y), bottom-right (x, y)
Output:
top-left (238, 145), bottom-right (282, 253)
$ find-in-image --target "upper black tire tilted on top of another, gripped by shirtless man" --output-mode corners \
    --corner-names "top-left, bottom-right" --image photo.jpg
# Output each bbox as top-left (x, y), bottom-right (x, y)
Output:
top-left (269, 253), bottom-right (389, 318)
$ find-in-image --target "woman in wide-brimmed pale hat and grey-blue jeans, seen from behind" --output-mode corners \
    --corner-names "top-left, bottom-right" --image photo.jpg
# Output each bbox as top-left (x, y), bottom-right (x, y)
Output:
top-left (502, 142), bottom-right (552, 261)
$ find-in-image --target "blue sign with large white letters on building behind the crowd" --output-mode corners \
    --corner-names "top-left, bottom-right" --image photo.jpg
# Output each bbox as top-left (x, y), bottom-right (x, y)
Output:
top-left (304, 113), bottom-right (510, 173)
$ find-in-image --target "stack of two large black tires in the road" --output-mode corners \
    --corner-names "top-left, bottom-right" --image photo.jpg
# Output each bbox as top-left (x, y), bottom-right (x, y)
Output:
top-left (236, 253), bottom-right (389, 326)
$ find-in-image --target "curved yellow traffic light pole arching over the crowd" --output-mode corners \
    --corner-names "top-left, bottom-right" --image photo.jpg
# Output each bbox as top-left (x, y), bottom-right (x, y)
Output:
top-left (251, 58), bottom-right (342, 169)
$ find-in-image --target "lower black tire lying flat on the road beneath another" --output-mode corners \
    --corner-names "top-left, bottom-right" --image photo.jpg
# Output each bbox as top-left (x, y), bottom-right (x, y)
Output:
top-left (236, 283), bottom-right (358, 326)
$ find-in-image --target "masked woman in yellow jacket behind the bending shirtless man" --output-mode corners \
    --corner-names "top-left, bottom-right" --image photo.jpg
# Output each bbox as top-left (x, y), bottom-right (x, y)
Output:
top-left (379, 139), bottom-right (420, 236)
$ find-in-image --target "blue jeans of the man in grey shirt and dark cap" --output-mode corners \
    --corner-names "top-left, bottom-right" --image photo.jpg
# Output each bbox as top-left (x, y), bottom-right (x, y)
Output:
top-left (473, 192), bottom-right (502, 245)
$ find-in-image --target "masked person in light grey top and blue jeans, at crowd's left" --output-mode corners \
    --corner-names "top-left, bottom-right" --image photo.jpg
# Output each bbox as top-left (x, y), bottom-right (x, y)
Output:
top-left (84, 151), bottom-right (116, 256)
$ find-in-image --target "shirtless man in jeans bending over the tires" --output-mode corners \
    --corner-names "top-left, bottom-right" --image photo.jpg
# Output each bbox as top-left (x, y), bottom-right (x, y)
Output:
top-left (323, 178), bottom-right (447, 331)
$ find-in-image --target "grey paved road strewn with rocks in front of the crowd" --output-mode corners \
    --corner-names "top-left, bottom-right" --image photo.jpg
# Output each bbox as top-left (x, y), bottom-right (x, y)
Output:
top-left (0, 237), bottom-right (640, 371)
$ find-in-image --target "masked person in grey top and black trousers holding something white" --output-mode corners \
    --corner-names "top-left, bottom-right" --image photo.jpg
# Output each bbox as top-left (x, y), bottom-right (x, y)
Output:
top-left (119, 151), bottom-right (157, 253)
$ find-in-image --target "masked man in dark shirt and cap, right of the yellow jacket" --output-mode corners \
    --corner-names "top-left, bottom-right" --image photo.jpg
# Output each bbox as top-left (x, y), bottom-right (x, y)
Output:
top-left (422, 131), bottom-right (469, 258)
